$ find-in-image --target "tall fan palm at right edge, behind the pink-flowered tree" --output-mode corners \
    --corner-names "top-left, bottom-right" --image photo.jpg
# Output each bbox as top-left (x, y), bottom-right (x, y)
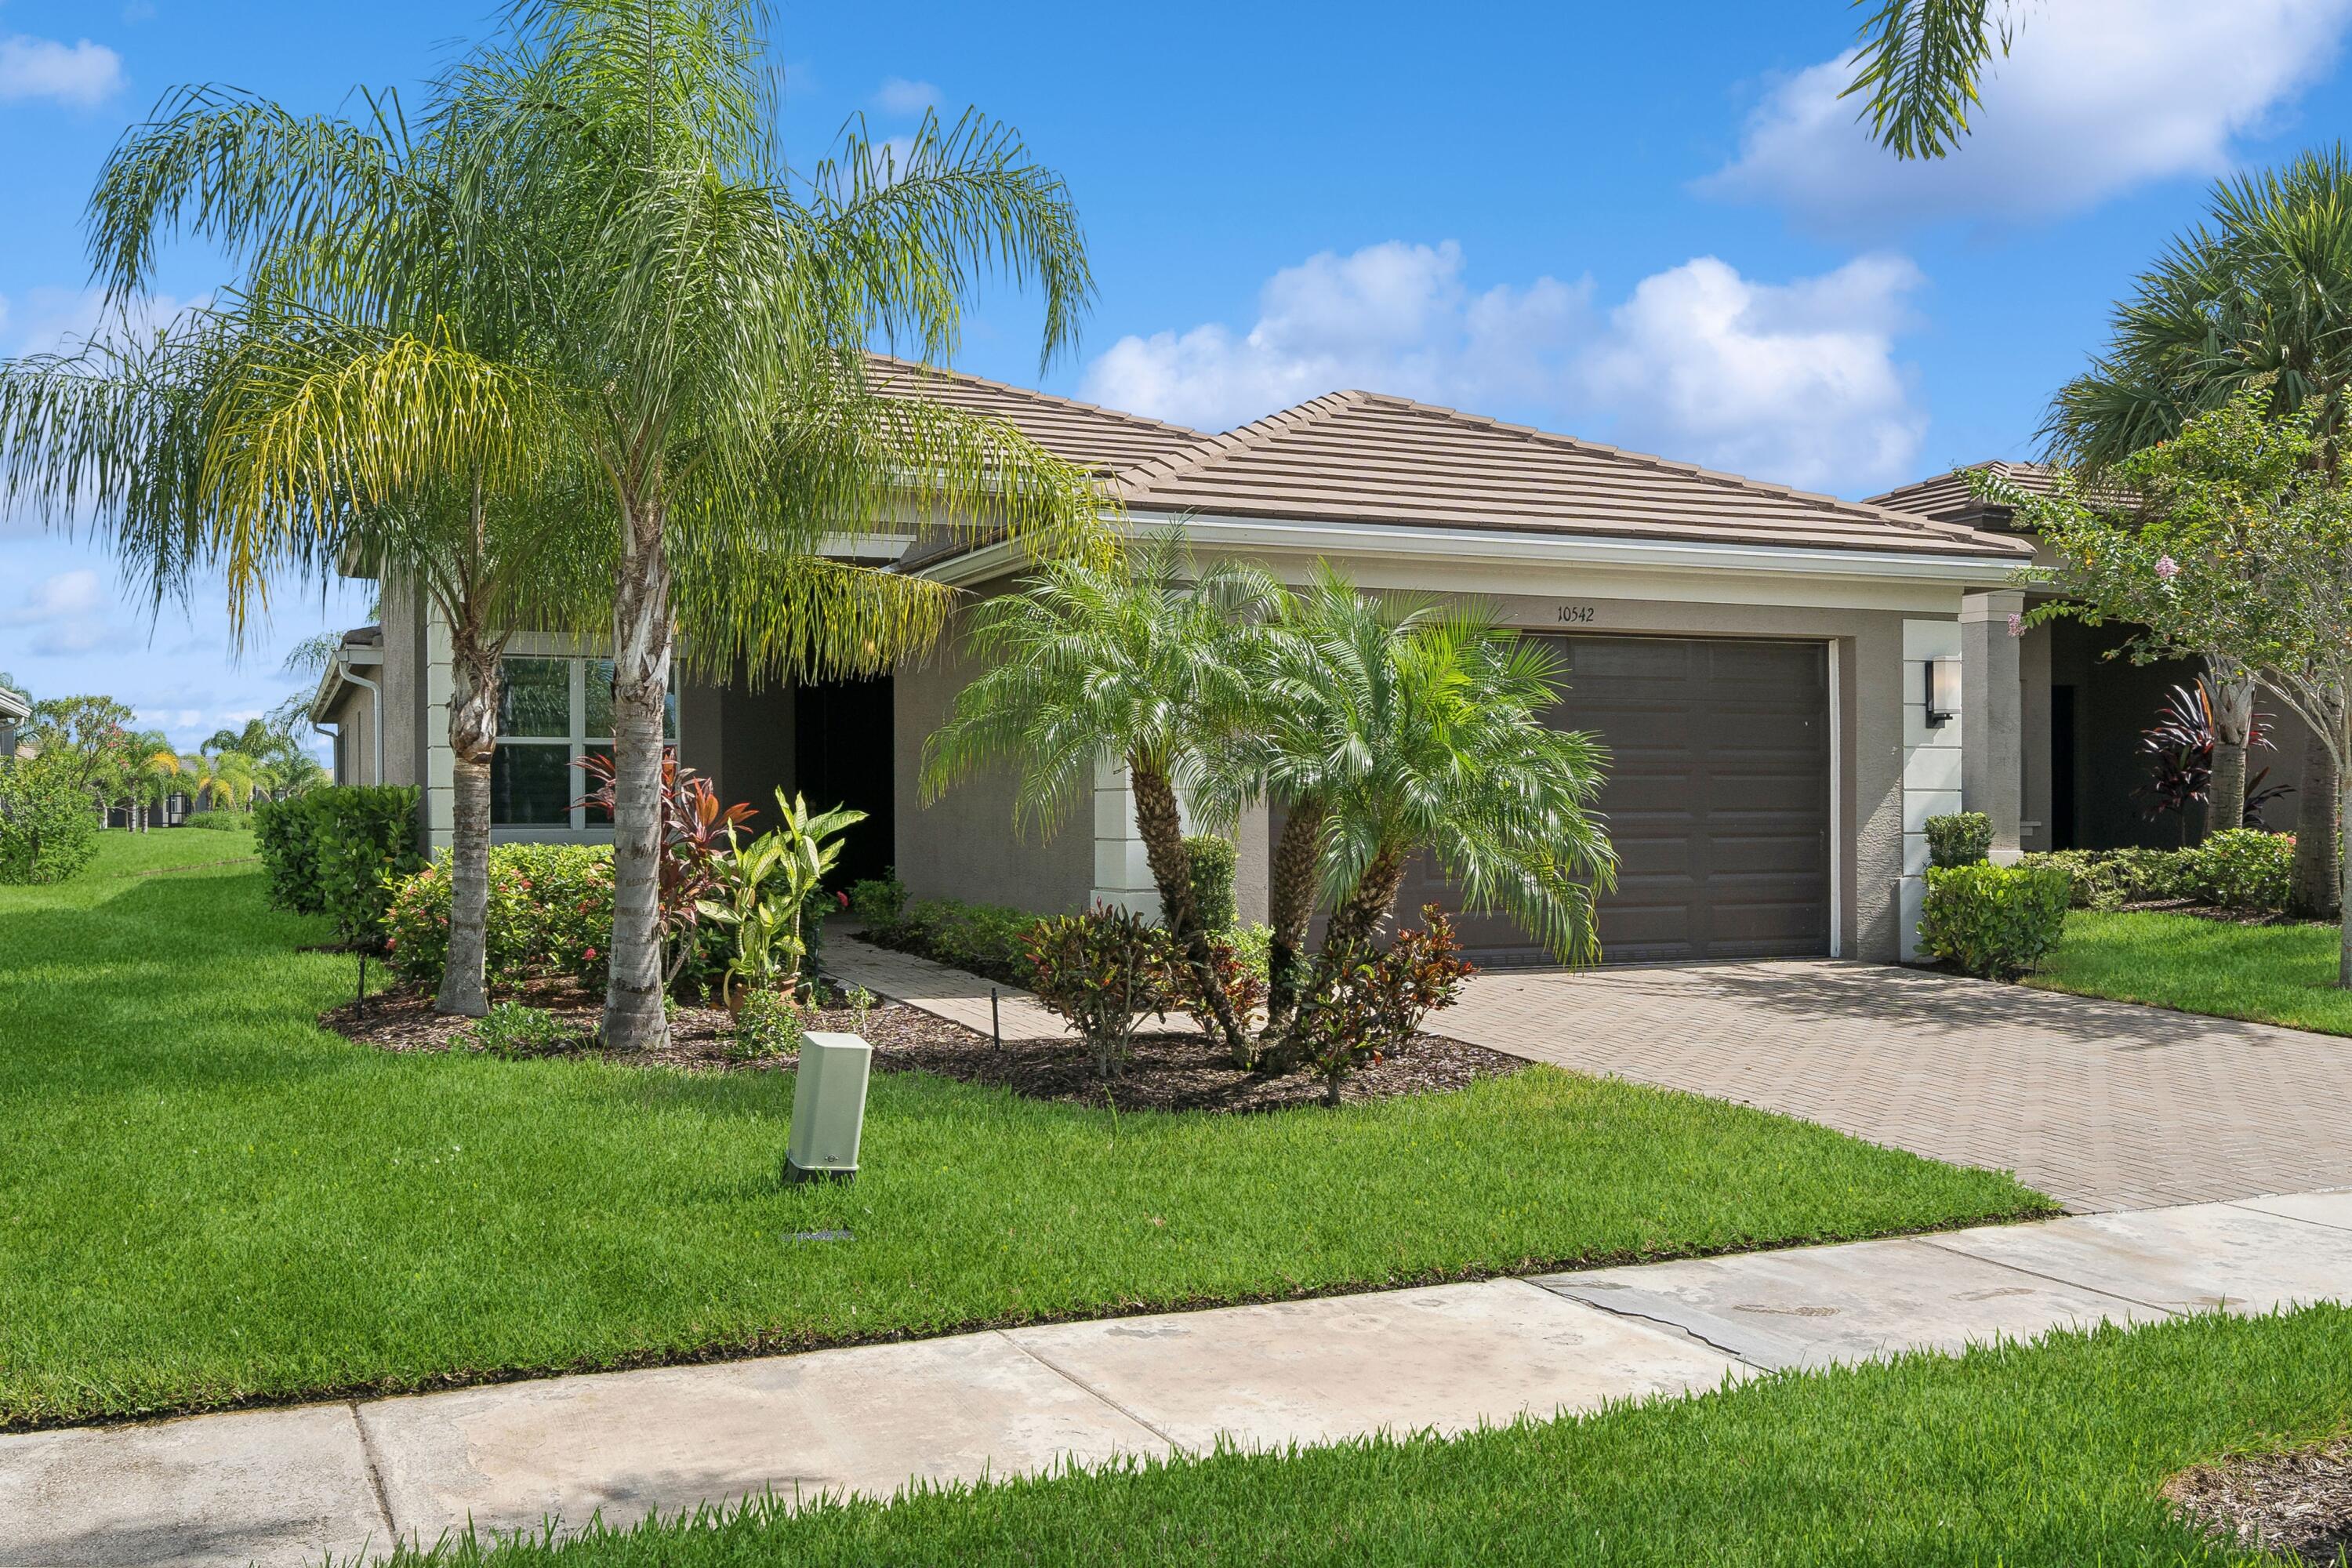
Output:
top-left (2042, 146), bottom-right (2352, 914)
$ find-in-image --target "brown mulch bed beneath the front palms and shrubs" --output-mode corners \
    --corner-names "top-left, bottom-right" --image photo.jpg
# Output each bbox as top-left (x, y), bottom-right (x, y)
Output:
top-left (318, 982), bottom-right (1526, 1112)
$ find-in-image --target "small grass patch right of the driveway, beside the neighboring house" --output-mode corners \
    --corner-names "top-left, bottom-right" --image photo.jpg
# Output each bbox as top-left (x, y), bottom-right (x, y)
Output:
top-left (2027, 909), bottom-right (2352, 1034)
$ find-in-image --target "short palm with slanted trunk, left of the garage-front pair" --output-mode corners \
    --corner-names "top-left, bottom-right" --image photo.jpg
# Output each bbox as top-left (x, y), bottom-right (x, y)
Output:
top-left (922, 534), bottom-right (1254, 1060)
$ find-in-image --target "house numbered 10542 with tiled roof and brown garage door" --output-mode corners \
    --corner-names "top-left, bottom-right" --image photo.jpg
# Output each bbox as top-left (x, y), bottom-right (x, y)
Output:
top-left (310, 362), bottom-right (2030, 961)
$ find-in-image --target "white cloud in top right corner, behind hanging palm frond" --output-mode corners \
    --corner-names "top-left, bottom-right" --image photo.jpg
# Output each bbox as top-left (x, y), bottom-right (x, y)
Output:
top-left (1698, 0), bottom-right (2352, 233)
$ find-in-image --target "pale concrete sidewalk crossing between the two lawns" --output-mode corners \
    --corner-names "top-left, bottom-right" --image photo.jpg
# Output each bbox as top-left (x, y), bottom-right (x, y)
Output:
top-left (0, 1192), bottom-right (2352, 1568)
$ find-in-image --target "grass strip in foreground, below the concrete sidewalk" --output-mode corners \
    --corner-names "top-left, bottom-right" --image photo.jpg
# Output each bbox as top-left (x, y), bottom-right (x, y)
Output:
top-left (367, 1307), bottom-right (2352, 1568)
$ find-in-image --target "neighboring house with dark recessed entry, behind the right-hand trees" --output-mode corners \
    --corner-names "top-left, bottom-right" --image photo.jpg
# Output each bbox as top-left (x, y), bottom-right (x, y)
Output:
top-left (1870, 463), bottom-right (2310, 848)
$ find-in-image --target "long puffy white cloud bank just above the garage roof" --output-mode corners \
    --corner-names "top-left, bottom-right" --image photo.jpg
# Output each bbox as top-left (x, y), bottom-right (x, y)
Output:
top-left (1082, 242), bottom-right (1926, 494)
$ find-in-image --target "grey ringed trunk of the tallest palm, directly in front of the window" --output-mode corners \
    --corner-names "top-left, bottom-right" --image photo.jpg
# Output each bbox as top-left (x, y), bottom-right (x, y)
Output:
top-left (604, 503), bottom-right (670, 1051)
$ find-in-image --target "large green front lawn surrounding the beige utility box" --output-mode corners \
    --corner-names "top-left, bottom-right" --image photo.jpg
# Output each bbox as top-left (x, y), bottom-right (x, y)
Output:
top-left (0, 832), bottom-right (2046, 1425)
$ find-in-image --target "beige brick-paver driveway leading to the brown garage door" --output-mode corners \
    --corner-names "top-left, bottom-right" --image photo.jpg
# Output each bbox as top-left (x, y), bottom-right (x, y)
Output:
top-left (1428, 961), bottom-right (2352, 1210)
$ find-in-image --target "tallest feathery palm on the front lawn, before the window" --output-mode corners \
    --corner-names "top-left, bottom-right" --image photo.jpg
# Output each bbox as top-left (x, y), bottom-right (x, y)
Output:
top-left (16, 0), bottom-right (1101, 1048)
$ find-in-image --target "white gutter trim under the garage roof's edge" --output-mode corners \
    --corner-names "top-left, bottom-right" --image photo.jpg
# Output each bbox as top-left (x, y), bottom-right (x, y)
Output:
top-left (913, 513), bottom-right (2032, 588)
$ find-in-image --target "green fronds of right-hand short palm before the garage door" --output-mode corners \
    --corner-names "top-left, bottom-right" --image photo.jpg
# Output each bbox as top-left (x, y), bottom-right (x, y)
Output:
top-left (1251, 564), bottom-right (1616, 1048)
